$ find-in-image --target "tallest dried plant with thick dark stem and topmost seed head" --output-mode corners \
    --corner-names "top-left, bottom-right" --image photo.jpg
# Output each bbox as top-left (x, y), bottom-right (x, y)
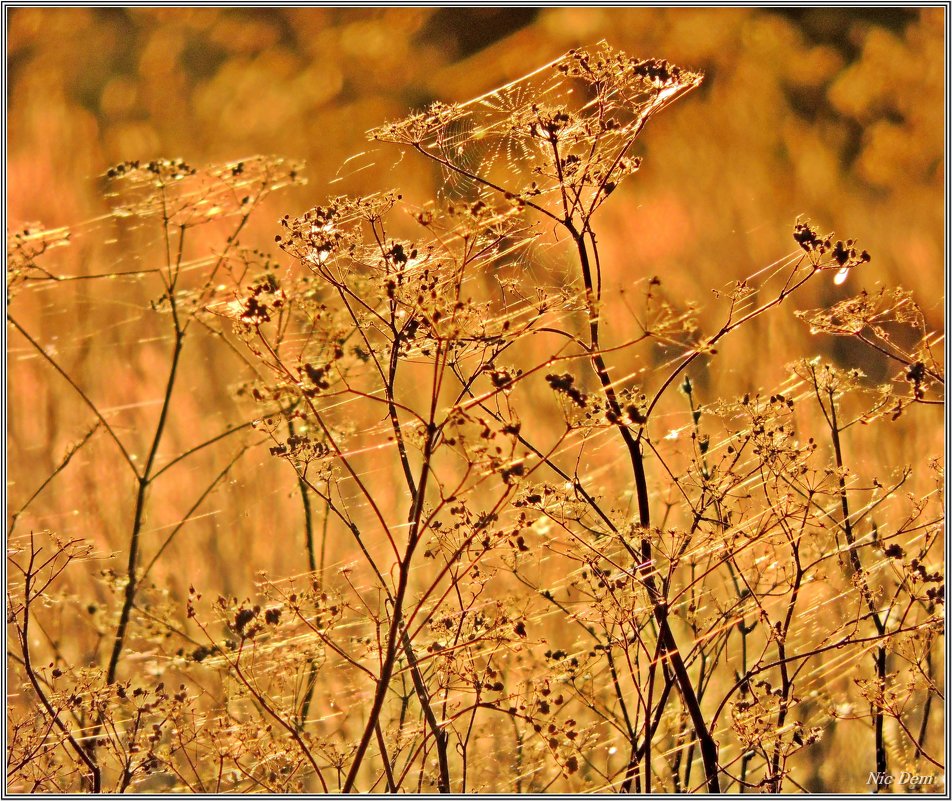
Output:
top-left (376, 49), bottom-right (720, 792)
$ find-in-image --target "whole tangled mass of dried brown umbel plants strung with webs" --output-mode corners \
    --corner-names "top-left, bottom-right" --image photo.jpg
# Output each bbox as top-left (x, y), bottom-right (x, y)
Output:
top-left (8, 44), bottom-right (944, 793)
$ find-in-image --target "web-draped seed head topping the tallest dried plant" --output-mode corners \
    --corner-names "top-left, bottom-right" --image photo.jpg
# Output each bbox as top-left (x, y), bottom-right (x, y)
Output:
top-left (369, 44), bottom-right (701, 220)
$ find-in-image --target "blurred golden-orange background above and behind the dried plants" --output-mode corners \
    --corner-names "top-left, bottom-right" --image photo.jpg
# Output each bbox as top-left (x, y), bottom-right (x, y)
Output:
top-left (7, 7), bottom-right (946, 792)
